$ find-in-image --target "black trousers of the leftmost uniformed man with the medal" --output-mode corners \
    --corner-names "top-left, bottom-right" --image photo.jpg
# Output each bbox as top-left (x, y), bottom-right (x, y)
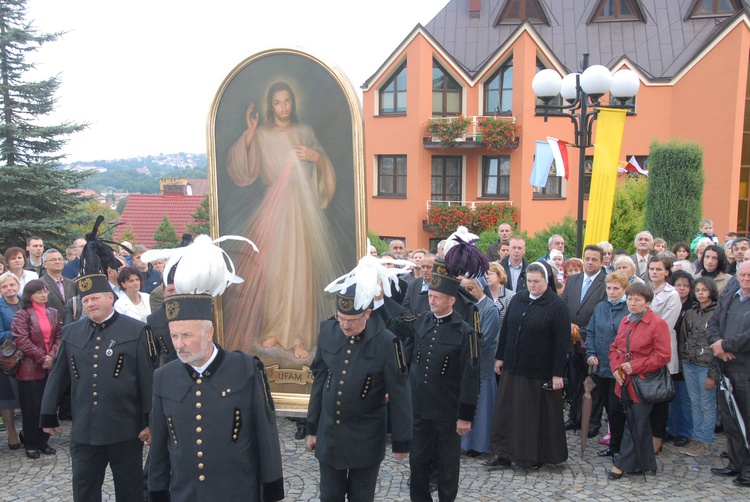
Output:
top-left (70, 438), bottom-right (143, 502)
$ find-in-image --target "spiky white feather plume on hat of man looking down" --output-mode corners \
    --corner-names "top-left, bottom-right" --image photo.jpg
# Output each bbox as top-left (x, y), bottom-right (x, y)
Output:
top-left (325, 255), bottom-right (414, 309)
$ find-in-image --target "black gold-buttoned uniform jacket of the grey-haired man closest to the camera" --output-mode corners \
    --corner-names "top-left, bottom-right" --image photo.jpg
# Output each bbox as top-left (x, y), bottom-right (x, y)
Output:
top-left (148, 346), bottom-right (284, 502)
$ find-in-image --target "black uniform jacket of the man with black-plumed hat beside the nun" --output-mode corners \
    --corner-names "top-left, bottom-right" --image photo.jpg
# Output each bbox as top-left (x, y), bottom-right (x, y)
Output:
top-left (377, 305), bottom-right (481, 421)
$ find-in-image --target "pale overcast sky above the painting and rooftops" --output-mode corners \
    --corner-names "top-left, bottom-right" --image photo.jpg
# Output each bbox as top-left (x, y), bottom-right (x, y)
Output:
top-left (28, 0), bottom-right (447, 161)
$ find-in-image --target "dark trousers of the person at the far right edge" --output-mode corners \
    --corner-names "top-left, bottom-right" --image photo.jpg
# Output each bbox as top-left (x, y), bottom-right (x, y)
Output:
top-left (720, 364), bottom-right (750, 476)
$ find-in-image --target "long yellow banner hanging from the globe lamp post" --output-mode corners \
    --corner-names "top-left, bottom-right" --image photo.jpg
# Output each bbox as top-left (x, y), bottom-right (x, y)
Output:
top-left (583, 108), bottom-right (627, 246)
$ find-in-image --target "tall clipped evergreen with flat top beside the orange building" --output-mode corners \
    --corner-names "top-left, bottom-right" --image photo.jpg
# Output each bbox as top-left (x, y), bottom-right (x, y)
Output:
top-left (644, 141), bottom-right (704, 244)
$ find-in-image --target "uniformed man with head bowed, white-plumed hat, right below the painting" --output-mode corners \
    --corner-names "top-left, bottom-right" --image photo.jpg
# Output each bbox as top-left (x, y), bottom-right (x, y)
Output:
top-left (307, 285), bottom-right (412, 502)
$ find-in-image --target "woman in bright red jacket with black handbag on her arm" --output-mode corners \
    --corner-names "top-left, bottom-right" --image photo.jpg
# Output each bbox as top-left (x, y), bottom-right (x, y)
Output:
top-left (607, 282), bottom-right (671, 479)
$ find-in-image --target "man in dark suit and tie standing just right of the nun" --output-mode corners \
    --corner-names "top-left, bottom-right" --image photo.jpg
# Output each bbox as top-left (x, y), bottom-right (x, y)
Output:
top-left (561, 244), bottom-right (607, 437)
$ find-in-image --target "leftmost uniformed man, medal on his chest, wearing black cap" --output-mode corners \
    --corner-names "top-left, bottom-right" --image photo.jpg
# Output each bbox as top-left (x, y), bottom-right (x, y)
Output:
top-left (41, 274), bottom-right (153, 502)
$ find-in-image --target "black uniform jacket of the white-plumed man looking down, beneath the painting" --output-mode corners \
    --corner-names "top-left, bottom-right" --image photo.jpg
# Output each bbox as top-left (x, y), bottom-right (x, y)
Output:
top-left (307, 314), bottom-right (412, 469)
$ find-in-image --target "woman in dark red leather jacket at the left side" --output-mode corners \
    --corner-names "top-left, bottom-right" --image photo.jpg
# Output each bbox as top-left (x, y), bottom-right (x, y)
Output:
top-left (10, 279), bottom-right (61, 460)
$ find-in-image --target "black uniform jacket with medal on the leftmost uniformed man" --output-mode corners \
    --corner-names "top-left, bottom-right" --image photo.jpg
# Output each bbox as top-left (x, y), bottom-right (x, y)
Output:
top-left (41, 312), bottom-right (153, 446)
